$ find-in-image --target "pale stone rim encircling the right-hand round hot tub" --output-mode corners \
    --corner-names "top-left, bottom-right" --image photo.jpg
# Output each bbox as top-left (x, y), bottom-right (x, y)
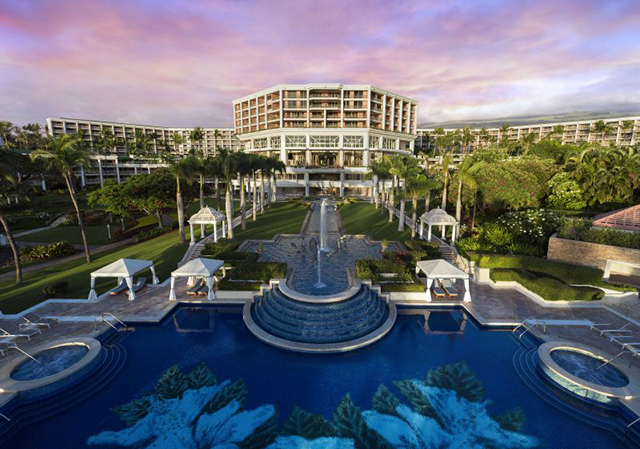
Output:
top-left (538, 340), bottom-right (640, 400)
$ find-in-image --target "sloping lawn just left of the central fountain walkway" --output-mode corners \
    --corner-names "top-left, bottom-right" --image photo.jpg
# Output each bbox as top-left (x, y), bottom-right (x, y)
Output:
top-left (234, 202), bottom-right (309, 242)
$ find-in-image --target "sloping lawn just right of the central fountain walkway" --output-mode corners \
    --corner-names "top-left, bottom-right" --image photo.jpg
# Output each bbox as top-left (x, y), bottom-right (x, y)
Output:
top-left (340, 203), bottom-right (411, 242)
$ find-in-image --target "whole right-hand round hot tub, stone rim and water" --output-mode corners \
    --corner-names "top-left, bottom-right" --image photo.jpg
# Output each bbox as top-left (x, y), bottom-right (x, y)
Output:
top-left (538, 342), bottom-right (640, 403)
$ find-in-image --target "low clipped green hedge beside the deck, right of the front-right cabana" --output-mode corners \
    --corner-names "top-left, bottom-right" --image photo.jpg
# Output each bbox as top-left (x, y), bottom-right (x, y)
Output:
top-left (490, 268), bottom-right (604, 301)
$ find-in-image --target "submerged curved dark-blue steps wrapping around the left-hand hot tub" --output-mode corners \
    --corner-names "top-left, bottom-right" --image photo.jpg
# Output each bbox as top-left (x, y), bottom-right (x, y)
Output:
top-left (0, 329), bottom-right (130, 445)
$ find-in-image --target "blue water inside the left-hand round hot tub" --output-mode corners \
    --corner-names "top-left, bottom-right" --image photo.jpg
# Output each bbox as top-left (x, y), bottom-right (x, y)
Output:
top-left (11, 345), bottom-right (89, 381)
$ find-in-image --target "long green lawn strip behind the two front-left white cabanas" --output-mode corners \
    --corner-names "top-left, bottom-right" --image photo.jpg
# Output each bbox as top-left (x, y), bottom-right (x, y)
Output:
top-left (0, 231), bottom-right (188, 313)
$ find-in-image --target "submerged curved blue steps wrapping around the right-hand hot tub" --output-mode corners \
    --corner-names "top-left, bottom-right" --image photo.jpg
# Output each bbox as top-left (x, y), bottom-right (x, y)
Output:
top-left (513, 335), bottom-right (640, 448)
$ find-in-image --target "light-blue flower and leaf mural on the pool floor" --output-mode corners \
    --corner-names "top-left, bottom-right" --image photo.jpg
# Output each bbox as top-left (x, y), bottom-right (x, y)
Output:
top-left (87, 362), bottom-right (539, 449)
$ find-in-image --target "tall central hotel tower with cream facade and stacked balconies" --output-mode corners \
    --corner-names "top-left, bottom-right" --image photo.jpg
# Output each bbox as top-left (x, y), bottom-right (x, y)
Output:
top-left (233, 84), bottom-right (418, 196)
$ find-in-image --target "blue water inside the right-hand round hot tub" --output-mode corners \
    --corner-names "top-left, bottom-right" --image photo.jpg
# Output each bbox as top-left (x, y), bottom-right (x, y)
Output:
top-left (551, 349), bottom-right (629, 388)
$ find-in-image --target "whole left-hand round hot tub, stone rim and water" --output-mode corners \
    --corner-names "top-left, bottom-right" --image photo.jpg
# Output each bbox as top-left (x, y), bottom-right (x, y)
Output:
top-left (0, 337), bottom-right (102, 395)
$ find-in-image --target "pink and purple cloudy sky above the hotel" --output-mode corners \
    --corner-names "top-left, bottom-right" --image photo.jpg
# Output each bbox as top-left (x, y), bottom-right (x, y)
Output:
top-left (0, 0), bottom-right (640, 127)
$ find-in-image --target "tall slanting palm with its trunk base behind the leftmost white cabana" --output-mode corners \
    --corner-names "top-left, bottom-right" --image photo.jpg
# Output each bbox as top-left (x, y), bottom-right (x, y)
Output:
top-left (31, 134), bottom-right (91, 263)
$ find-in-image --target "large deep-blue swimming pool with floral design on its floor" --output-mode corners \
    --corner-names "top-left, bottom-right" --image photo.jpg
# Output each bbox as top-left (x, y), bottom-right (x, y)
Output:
top-left (0, 307), bottom-right (626, 449)
